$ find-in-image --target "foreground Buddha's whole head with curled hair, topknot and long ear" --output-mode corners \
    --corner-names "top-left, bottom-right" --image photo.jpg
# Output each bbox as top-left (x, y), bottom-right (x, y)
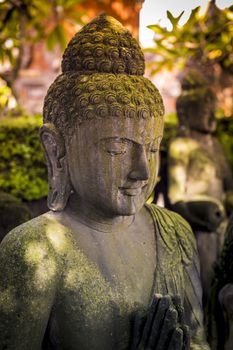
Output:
top-left (41, 15), bottom-right (163, 216)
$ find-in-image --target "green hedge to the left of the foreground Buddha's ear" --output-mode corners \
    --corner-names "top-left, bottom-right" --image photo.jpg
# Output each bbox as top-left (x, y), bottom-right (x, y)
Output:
top-left (0, 115), bottom-right (48, 200)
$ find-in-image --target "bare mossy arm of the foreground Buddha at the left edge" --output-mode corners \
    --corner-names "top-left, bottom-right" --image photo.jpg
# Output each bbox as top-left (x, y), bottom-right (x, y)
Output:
top-left (0, 229), bottom-right (56, 350)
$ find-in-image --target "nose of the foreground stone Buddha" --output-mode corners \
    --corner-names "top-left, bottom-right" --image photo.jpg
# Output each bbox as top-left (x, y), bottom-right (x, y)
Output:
top-left (128, 147), bottom-right (149, 181)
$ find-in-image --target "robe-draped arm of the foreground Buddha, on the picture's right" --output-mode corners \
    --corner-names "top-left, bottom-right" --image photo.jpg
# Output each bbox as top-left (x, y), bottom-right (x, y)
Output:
top-left (155, 208), bottom-right (209, 350)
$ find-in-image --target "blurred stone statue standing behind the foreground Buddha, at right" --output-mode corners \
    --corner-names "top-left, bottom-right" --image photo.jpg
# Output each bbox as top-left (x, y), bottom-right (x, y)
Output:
top-left (168, 71), bottom-right (233, 295)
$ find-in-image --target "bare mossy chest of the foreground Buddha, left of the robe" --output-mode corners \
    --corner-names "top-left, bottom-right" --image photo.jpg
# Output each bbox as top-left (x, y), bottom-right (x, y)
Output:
top-left (54, 226), bottom-right (155, 350)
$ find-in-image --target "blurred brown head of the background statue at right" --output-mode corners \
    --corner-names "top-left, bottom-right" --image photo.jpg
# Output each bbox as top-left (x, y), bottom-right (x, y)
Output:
top-left (176, 71), bottom-right (216, 133)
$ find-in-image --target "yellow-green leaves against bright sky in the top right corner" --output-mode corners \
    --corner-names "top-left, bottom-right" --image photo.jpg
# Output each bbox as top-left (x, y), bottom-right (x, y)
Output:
top-left (145, 1), bottom-right (233, 74)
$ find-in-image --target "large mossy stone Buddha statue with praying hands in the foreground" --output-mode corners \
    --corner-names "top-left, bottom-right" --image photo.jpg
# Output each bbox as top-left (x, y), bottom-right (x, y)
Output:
top-left (0, 15), bottom-right (208, 350)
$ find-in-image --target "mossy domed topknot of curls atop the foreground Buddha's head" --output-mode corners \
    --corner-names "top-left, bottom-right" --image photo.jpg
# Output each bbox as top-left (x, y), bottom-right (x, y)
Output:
top-left (62, 14), bottom-right (145, 75)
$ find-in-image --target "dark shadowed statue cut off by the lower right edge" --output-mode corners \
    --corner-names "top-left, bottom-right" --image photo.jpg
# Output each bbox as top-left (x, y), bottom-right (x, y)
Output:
top-left (207, 216), bottom-right (233, 350)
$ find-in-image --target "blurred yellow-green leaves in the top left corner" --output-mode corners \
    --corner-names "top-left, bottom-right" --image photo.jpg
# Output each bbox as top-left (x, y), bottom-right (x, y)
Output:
top-left (0, 0), bottom-right (83, 76)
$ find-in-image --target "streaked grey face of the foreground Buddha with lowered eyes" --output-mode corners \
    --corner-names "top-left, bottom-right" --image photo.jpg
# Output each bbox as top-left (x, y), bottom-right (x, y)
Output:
top-left (67, 117), bottom-right (163, 217)
